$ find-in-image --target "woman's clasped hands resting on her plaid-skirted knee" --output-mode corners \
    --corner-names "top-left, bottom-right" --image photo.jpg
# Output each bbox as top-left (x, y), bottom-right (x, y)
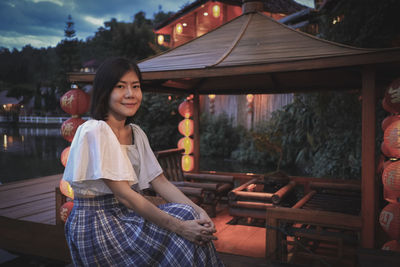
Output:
top-left (177, 219), bottom-right (217, 245)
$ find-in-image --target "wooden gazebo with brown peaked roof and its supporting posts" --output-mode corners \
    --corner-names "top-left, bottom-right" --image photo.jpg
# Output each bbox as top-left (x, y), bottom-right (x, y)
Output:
top-left (69, 2), bottom-right (400, 251)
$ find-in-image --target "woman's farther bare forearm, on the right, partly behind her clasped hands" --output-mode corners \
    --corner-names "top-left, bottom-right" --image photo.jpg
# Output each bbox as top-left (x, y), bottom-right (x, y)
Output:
top-left (151, 174), bottom-right (216, 232)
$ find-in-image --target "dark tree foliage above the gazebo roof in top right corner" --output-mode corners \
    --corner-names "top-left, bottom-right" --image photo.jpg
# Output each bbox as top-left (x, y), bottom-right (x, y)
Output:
top-left (316, 0), bottom-right (400, 47)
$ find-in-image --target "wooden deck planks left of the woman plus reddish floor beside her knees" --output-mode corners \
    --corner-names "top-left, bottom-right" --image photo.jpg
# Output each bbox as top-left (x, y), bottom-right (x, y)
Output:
top-left (0, 174), bottom-right (272, 267)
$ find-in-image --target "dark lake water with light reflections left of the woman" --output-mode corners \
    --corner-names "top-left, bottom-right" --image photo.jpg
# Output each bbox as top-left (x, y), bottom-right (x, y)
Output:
top-left (0, 126), bottom-right (70, 184)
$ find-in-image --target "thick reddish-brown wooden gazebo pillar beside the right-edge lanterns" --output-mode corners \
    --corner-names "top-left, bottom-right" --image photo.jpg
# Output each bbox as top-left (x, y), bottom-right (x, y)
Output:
top-left (361, 66), bottom-right (377, 248)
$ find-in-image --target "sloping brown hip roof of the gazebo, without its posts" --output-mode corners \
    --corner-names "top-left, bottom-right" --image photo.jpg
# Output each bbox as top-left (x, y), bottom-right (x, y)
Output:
top-left (134, 12), bottom-right (400, 94)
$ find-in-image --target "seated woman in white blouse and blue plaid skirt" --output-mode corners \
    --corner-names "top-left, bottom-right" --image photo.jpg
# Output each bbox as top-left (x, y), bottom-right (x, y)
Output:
top-left (63, 58), bottom-right (222, 266)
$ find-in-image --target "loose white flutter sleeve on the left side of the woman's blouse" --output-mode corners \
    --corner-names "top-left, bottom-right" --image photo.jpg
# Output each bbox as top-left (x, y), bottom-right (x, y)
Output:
top-left (63, 120), bottom-right (137, 193)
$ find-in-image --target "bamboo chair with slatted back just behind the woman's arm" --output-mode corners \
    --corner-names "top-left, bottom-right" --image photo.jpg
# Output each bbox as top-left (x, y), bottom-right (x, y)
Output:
top-left (155, 148), bottom-right (233, 217)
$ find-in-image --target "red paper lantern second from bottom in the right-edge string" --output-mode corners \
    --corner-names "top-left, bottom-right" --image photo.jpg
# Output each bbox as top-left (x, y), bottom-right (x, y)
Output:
top-left (379, 203), bottom-right (400, 240)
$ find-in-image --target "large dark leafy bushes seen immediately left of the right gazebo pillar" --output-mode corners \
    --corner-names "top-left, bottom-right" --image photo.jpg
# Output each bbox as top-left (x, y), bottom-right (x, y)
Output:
top-left (247, 92), bottom-right (361, 179)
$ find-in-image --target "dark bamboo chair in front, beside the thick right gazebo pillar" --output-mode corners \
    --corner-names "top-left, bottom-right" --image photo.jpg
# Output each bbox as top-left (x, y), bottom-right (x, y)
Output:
top-left (266, 182), bottom-right (362, 266)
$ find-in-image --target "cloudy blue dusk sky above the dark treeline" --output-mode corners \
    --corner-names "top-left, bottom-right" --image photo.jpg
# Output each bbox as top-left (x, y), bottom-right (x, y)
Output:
top-left (0, 0), bottom-right (313, 50)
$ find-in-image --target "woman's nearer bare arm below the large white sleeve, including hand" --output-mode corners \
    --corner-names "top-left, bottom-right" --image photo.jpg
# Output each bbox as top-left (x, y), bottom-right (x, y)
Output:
top-left (103, 179), bottom-right (216, 245)
